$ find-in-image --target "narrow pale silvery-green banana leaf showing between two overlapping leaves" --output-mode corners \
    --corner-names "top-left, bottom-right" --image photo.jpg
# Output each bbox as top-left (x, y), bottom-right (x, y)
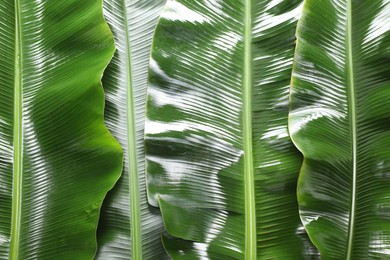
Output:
top-left (96, 0), bottom-right (168, 260)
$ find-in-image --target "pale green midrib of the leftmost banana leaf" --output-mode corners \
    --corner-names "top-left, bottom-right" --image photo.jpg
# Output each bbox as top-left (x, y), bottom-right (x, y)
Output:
top-left (9, 0), bottom-right (23, 260)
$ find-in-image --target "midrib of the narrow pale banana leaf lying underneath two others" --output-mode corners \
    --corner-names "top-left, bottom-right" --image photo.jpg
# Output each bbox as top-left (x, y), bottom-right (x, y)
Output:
top-left (122, 1), bottom-right (142, 259)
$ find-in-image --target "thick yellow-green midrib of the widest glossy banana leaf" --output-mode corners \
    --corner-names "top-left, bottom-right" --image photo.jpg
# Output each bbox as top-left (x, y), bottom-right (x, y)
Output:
top-left (243, 0), bottom-right (257, 260)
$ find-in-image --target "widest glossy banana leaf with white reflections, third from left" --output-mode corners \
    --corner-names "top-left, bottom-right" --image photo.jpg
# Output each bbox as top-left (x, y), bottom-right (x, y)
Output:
top-left (145, 0), bottom-right (317, 260)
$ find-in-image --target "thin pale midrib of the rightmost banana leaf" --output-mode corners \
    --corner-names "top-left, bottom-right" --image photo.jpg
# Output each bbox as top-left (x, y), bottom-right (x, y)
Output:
top-left (346, 0), bottom-right (357, 260)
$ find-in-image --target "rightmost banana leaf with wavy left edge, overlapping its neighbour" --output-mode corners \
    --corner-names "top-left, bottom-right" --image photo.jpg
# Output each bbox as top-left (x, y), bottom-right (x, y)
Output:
top-left (289, 0), bottom-right (390, 260)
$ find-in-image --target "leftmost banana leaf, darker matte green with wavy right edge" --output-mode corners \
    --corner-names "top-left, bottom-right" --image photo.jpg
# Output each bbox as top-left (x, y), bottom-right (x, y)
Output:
top-left (0, 0), bottom-right (122, 260)
